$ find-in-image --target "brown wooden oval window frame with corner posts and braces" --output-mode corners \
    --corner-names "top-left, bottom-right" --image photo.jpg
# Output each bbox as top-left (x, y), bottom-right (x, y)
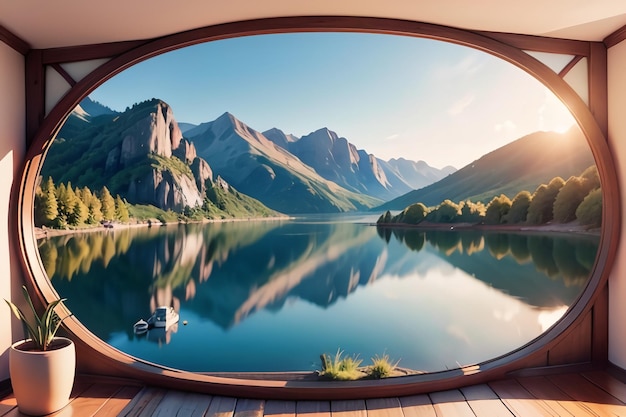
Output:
top-left (11, 17), bottom-right (620, 399)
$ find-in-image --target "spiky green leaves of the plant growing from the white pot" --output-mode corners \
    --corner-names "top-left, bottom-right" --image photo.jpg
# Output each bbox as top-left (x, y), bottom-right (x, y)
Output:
top-left (4, 286), bottom-right (66, 351)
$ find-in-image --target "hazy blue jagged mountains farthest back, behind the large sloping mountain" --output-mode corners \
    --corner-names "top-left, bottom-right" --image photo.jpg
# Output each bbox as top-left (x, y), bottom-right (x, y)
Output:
top-left (263, 128), bottom-right (454, 200)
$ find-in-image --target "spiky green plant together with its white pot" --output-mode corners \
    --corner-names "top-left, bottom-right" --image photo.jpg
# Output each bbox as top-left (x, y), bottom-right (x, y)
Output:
top-left (5, 286), bottom-right (76, 415)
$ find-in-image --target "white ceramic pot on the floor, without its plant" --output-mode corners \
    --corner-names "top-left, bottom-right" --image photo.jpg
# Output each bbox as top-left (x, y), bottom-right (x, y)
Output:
top-left (9, 337), bottom-right (76, 416)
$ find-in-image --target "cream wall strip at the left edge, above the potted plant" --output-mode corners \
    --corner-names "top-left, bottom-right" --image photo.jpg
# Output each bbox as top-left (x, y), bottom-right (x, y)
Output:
top-left (0, 42), bottom-right (26, 381)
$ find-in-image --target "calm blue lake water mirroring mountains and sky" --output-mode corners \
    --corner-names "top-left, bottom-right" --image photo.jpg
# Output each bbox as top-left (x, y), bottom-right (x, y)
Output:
top-left (40, 213), bottom-right (598, 372)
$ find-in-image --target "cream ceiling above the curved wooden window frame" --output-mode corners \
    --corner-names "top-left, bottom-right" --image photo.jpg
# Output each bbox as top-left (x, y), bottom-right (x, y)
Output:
top-left (0, 0), bottom-right (626, 49)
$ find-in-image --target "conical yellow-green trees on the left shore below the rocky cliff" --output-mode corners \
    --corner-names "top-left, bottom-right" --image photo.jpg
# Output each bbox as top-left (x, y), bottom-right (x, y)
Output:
top-left (35, 177), bottom-right (130, 229)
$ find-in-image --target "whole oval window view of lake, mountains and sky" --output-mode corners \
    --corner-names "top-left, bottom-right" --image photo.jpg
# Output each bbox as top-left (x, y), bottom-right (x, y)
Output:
top-left (35, 33), bottom-right (602, 378)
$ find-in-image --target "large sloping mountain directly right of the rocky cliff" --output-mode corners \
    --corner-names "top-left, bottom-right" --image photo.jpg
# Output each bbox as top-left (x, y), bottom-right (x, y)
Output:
top-left (186, 113), bottom-right (381, 213)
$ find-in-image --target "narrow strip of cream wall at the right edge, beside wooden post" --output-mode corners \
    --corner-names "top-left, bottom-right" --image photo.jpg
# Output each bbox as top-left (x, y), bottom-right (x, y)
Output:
top-left (608, 41), bottom-right (626, 369)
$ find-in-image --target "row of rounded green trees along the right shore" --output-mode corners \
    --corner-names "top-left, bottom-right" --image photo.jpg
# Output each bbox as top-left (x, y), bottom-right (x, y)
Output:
top-left (377, 165), bottom-right (602, 227)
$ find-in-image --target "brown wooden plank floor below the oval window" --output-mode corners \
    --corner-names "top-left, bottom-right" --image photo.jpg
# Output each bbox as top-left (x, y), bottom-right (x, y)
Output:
top-left (0, 371), bottom-right (626, 417)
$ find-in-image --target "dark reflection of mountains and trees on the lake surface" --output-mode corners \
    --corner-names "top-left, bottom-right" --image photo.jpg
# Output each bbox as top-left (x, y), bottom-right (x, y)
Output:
top-left (39, 221), bottom-right (598, 340)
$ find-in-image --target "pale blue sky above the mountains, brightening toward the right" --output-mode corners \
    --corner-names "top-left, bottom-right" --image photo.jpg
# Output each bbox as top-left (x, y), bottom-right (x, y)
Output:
top-left (90, 33), bottom-right (573, 168)
